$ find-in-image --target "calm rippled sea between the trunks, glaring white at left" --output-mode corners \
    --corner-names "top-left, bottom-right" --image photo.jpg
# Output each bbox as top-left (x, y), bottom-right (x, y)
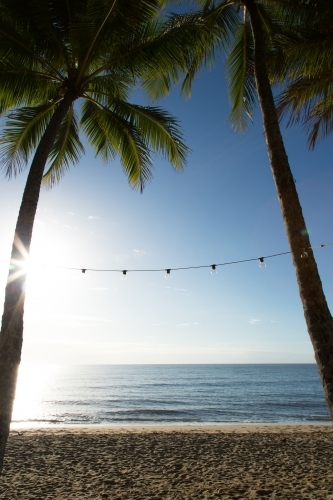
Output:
top-left (13, 364), bottom-right (329, 427)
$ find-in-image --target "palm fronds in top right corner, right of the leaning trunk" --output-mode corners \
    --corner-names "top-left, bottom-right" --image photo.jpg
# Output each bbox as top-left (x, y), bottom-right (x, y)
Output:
top-left (271, 0), bottom-right (333, 149)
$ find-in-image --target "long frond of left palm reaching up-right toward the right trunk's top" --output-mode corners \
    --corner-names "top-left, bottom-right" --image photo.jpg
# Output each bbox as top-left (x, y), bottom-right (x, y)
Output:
top-left (86, 0), bottom-right (235, 92)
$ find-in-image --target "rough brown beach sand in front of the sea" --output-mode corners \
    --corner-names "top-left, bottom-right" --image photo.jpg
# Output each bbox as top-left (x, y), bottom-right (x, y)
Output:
top-left (0, 425), bottom-right (333, 500)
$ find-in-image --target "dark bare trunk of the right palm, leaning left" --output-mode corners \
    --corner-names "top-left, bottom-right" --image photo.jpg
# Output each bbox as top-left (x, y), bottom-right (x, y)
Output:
top-left (243, 0), bottom-right (333, 419)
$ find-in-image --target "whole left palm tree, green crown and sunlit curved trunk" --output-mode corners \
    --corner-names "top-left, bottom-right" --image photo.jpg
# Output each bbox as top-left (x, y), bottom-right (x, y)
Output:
top-left (0, 0), bottom-right (226, 472)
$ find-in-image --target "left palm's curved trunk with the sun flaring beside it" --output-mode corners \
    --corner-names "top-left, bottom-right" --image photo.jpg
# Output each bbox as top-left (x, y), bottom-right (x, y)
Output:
top-left (0, 93), bottom-right (75, 474)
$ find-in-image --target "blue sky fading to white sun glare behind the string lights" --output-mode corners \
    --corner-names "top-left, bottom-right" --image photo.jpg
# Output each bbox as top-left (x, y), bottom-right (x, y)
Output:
top-left (0, 57), bottom-right (333, 364)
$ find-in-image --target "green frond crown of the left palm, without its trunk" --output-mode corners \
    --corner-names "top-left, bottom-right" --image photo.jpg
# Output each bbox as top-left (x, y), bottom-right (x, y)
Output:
top-left (0, 0), bottom-right (192, 189)
